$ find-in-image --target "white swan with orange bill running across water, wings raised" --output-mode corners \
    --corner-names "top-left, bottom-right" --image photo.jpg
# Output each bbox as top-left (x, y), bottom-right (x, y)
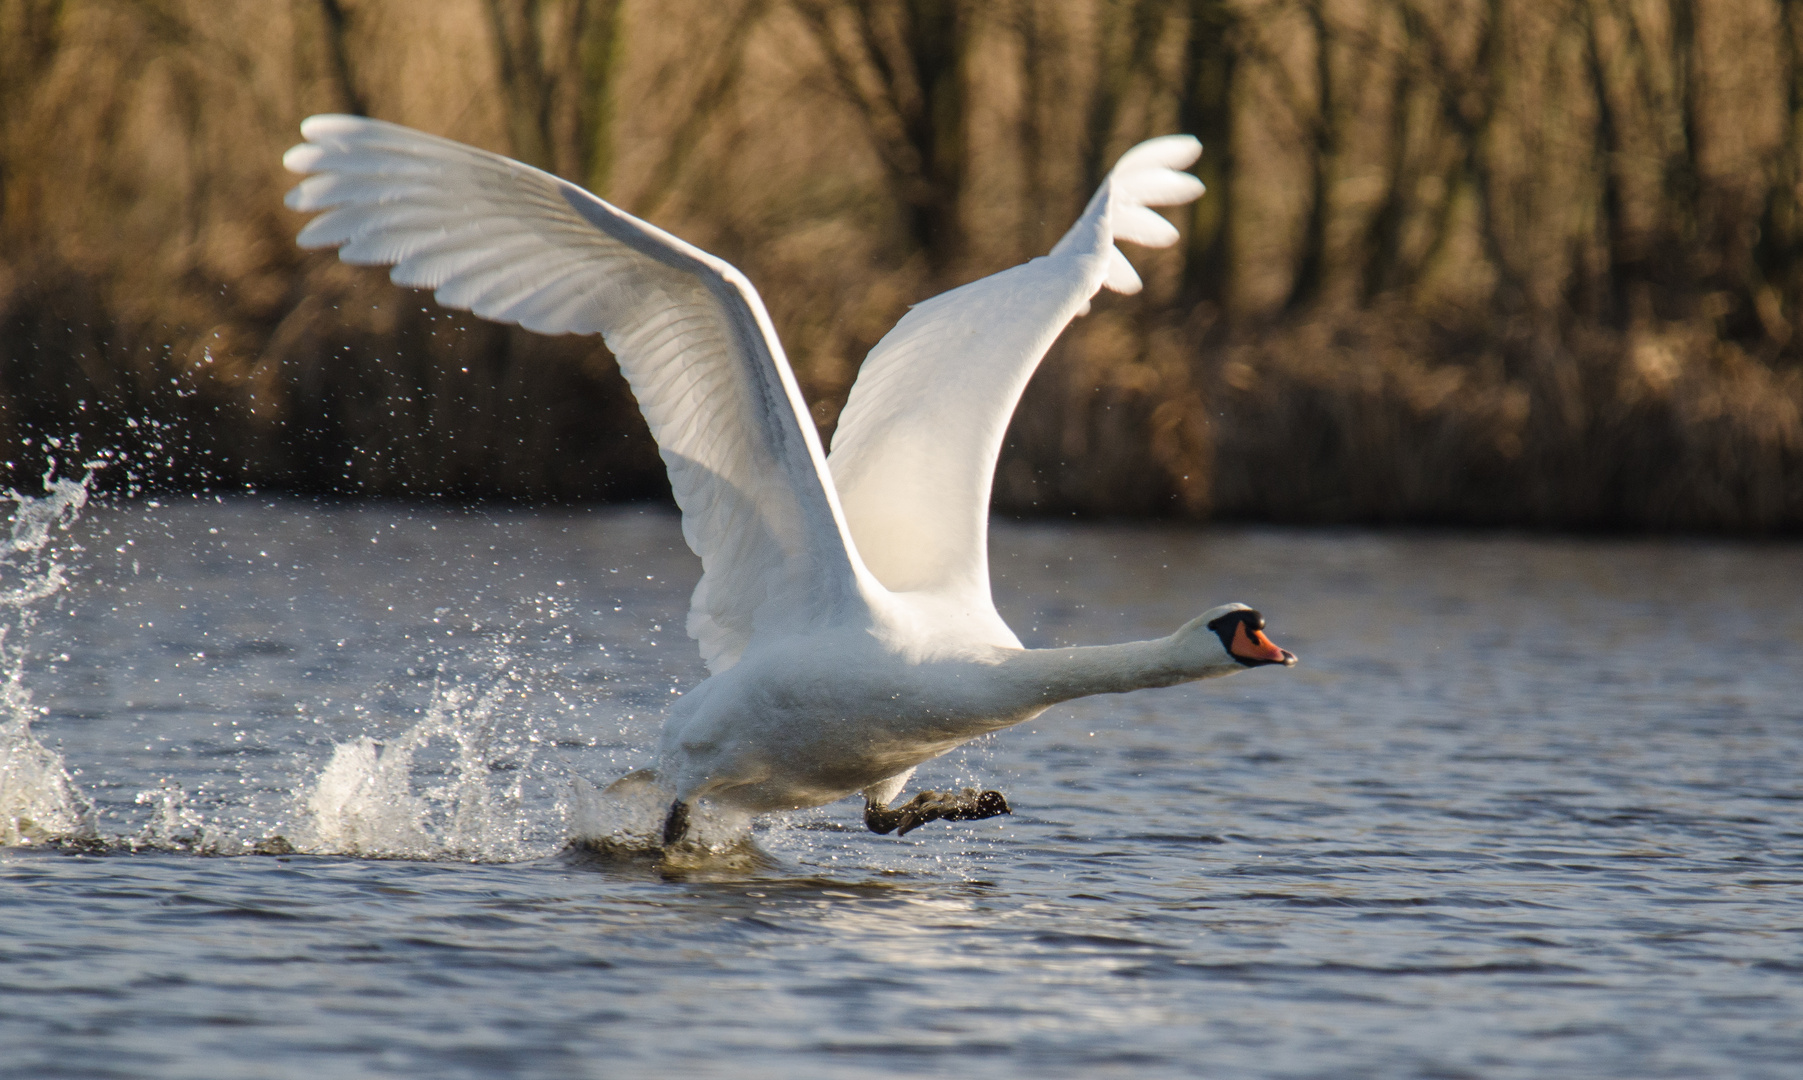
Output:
top-left (283, 115), bottom-right (1296, 846)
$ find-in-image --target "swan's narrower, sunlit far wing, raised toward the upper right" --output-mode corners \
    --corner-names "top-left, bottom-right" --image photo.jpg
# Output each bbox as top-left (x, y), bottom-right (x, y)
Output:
top-left (828, 135), bottom-right (1203, 613)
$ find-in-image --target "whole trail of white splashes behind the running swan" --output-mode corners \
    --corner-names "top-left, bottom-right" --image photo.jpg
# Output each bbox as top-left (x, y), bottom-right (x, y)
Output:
top-left (0, 478), bottom-right (695, 862)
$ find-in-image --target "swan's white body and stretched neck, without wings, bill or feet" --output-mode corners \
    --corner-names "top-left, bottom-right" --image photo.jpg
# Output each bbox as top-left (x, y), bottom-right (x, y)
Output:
top-left (664, 599), bottom-right (1244, 811)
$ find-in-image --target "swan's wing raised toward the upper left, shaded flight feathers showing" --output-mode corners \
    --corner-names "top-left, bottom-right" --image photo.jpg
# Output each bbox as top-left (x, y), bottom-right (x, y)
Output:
top-left (283, 115), bottom-right (867, 671)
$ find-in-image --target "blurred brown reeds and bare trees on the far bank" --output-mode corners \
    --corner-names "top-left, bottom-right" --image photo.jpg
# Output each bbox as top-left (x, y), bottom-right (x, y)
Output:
top-left (0, 0), bottom-right (1803, 534)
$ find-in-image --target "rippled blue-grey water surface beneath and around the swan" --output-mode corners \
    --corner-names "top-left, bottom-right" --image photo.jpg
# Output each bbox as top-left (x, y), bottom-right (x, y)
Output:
top-left (0, 492), bottom-right (1803, 1080)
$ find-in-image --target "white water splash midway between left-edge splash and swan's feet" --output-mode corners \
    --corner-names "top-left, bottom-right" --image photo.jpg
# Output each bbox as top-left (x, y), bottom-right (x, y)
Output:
top-left (301, 656), bottom-right (541, 862)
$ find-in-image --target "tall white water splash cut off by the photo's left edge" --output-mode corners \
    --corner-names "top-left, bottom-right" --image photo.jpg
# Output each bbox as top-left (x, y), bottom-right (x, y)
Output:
top-left (0, 467), bottom-right (94, 846)
